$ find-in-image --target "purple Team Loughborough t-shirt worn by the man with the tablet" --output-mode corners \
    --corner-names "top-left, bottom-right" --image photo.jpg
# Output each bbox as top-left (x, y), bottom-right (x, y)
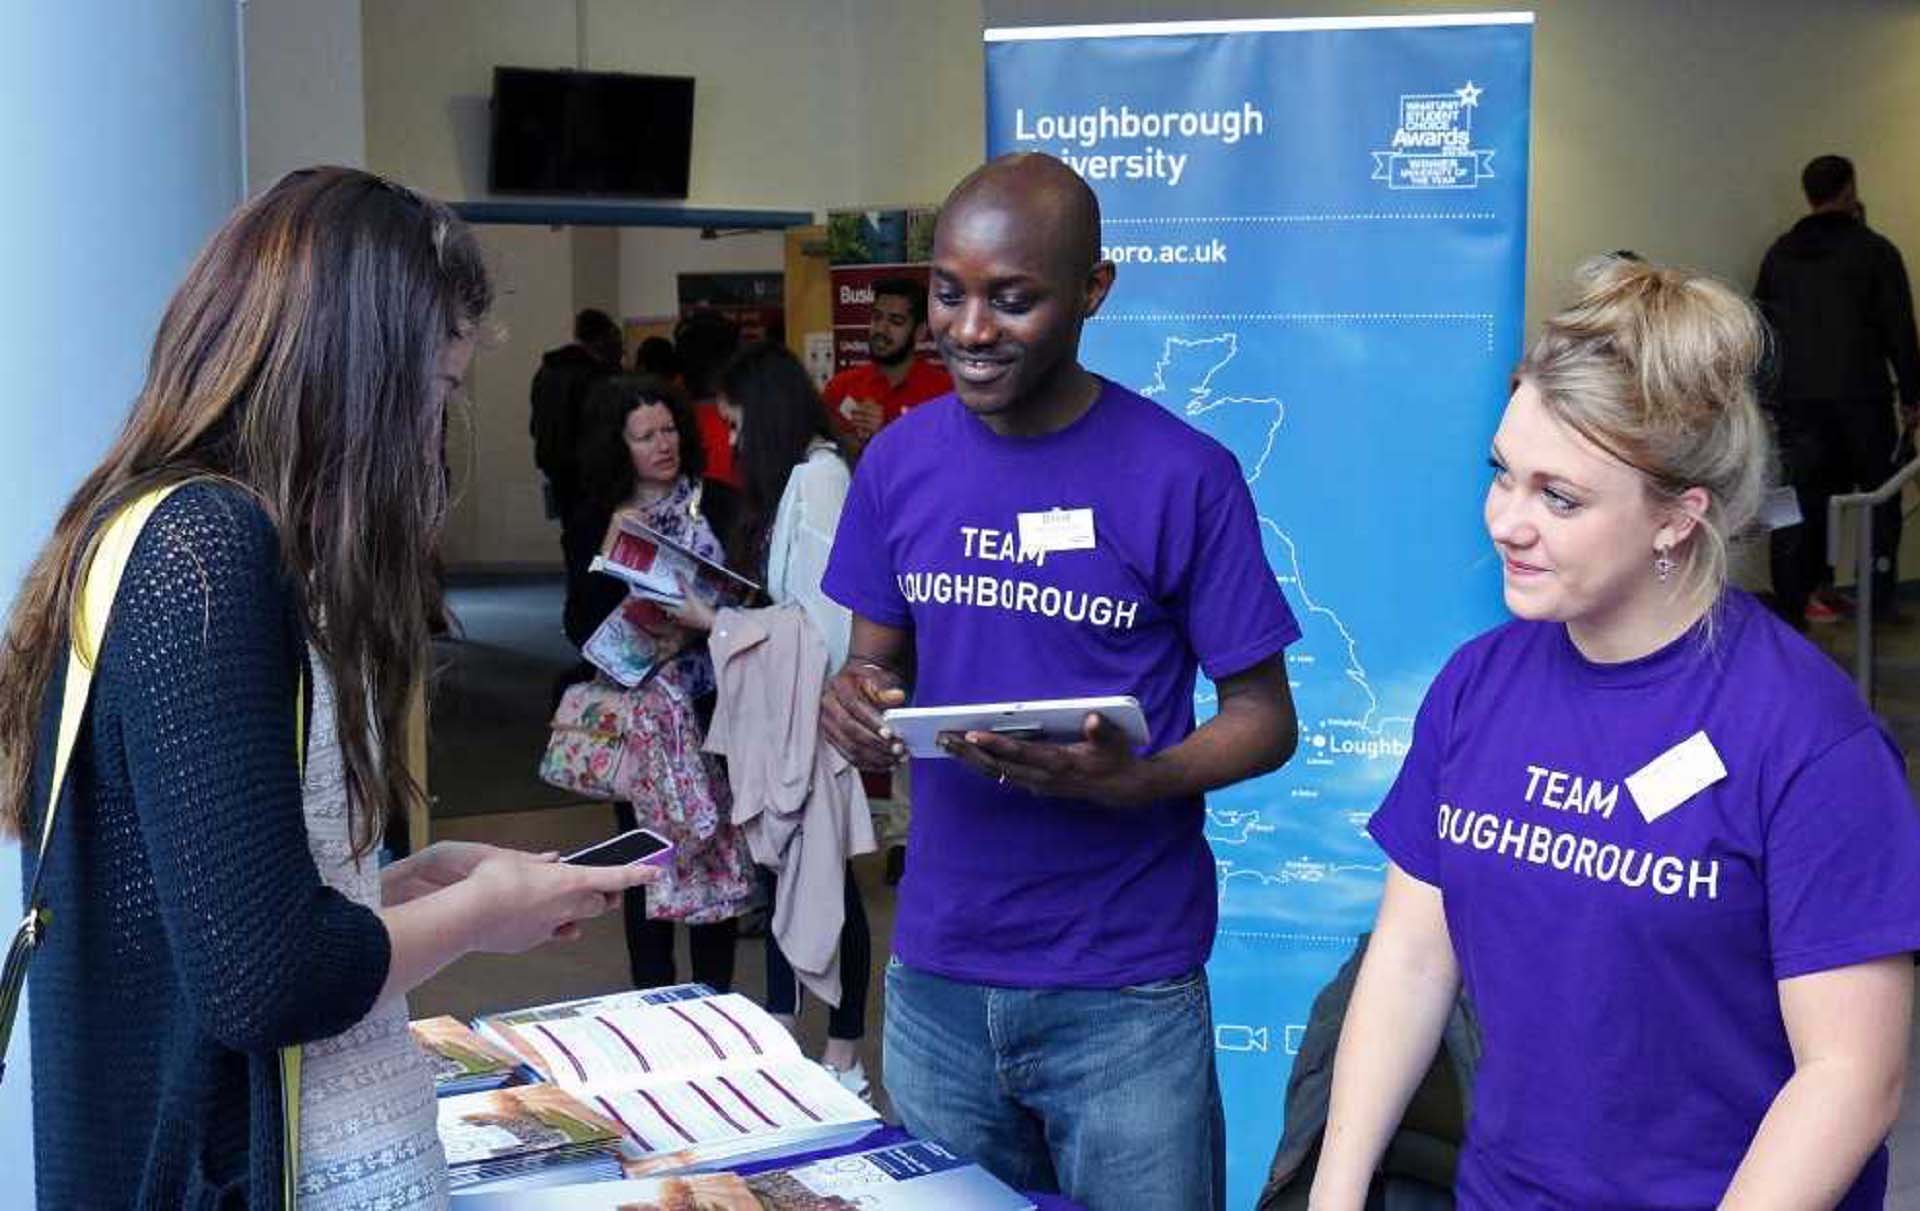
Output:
top-left (824, 382), bottom-right (1300, 988)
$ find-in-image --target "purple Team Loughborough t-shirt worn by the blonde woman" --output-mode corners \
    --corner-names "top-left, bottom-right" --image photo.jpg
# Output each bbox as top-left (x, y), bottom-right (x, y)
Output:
top-left (1369, 589), bottom-right (1920, 1209)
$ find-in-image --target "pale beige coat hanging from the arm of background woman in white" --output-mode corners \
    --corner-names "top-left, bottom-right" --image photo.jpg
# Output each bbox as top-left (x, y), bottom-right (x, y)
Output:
top-left (707, 605), bottom-right (874, 1006)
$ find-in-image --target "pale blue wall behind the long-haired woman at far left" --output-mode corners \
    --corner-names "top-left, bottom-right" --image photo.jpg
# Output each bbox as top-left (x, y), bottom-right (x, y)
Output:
top-left (0, 0), bottom-right (242, 1205)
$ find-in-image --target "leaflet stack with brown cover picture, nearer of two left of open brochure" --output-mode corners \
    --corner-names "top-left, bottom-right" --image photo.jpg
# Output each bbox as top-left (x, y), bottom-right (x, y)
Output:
top-left (440, 1084), bottom-right (620, 1190)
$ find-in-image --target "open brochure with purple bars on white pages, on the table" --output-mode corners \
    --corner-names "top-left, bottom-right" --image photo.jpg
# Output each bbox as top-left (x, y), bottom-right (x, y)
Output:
top-left (476, 992), bottom-right (877, 1176)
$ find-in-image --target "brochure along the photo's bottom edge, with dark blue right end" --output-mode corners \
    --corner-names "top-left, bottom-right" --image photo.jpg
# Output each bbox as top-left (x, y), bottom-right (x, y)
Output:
top-left (453, 1140), bottom-right (1033, 1211)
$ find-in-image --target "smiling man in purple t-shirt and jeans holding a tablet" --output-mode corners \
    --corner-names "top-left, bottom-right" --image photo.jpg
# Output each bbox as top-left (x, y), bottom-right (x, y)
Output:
top-left (822, 155), bottom-right (1300, 1211)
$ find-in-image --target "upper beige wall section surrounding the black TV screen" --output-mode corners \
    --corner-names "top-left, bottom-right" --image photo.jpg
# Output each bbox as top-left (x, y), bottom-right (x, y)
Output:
top-left (364, 0), bottom-right (981, 209)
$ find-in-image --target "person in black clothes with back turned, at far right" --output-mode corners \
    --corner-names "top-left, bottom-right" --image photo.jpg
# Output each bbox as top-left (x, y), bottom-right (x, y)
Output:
top-left (1753, 155), bottom-right (1920, 628)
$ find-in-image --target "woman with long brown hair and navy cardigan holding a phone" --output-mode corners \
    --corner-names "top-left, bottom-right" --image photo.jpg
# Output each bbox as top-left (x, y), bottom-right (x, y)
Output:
top-left (0, 169), bottom-right (645, 1207)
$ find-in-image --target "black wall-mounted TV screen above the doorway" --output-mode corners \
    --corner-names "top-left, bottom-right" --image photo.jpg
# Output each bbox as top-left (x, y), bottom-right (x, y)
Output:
top-left (488, 67), bottom-right (693, 198)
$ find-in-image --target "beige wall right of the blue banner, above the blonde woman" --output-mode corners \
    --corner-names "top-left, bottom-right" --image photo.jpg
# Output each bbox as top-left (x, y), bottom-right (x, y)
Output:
top-left (1528, 0), bottom-right (1920, 332)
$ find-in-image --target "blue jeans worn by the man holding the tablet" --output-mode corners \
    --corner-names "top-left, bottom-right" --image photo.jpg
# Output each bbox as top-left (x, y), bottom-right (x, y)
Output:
top-left (885, 960), bottom-right (1227, 1211)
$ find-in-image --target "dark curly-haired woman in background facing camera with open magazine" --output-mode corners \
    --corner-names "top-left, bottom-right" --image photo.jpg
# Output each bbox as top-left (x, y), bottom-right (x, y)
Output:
top-left (563, 374), bottom-right (755, 992)
